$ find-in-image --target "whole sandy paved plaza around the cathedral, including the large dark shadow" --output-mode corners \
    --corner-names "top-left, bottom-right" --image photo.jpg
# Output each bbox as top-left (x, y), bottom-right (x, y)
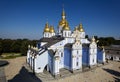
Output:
top-left (0, 57), bottom-right (120, 82)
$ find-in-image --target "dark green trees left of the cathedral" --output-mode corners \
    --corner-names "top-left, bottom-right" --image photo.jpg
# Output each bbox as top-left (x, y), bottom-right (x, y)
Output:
top-left (0, 39), bottom-right (37, 55)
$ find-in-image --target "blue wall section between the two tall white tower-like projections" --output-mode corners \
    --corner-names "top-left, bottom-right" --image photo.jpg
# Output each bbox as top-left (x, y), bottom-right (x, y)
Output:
top-left (82, 47), bottom-right (89, 66)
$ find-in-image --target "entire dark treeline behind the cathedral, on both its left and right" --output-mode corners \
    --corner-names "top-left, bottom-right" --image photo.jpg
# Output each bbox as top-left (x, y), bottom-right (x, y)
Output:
top-left (0, 35), bottom-right (120, 55)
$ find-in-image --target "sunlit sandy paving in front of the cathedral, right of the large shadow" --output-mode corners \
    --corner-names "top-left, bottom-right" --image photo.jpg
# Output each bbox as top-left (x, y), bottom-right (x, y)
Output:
top-left (38, 61), bottom-right (120, 82)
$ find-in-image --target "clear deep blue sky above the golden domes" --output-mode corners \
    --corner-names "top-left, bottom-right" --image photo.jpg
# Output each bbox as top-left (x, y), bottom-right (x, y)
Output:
top-left (0, 0), bottom-right (120, 39)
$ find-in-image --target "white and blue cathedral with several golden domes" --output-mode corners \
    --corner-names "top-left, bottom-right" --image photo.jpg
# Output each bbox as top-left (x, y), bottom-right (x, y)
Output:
top-left (27, 9), bottom-right (105, 76)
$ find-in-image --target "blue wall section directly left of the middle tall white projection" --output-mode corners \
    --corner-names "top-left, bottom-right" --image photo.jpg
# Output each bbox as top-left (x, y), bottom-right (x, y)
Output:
top-left (64, 48), bottom-right (71, 69)
